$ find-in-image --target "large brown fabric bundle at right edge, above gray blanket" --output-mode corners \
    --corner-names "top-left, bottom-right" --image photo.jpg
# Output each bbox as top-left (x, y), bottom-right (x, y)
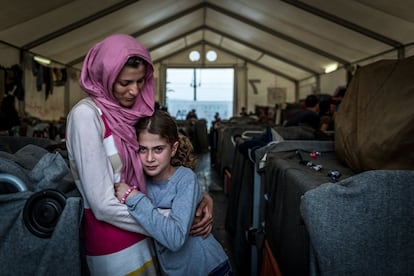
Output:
top-left (335, 57), bottom-right (414, 172)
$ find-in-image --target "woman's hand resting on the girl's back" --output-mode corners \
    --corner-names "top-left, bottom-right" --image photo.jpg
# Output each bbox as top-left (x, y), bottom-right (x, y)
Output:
top-left (190, 193), bottom-right (213, 239)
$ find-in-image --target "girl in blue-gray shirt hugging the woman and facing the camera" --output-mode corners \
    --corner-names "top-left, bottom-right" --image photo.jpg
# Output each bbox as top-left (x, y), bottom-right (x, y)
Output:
top-left (115, 111), bottom-right (232, 276)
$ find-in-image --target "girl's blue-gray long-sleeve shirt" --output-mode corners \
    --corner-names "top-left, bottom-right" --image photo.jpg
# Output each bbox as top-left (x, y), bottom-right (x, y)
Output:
top-left (126, 167), bottom-right (227, 276)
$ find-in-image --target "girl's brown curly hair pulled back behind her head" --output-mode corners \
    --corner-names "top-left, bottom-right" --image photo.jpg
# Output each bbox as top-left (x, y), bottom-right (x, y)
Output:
top-left (135, 110), bottom-right (197, 169)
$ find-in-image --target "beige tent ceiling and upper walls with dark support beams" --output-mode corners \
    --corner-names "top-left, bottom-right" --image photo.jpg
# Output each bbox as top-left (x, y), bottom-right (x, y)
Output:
top-left (0, 0), bottom-right (414, 119)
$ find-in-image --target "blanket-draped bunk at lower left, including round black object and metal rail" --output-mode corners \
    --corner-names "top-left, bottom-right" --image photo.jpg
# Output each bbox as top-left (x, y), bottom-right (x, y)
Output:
top-left (0, 144), bottom-right (85, 276)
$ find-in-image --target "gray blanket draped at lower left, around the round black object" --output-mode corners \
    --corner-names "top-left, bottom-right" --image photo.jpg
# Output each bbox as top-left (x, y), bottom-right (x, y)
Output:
top-left (0, 145), bottom-right (82, 275)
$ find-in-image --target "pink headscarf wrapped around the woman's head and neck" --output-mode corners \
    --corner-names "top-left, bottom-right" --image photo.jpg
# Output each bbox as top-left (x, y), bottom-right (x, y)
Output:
top-left (79, 34), bottom-right (155, 192)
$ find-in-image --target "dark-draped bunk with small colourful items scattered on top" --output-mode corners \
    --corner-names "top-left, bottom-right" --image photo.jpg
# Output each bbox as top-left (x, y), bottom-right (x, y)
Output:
top-left (256, 141), bottom-right (352, 275)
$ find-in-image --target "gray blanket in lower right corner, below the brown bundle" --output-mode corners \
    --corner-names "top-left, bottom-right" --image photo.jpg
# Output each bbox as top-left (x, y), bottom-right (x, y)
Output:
top-left (301, 170), bottom-right (414, 275)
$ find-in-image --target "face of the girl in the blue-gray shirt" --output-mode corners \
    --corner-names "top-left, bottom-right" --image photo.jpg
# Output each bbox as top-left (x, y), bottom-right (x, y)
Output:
top-left (138, 130), bottom-right (178, 181)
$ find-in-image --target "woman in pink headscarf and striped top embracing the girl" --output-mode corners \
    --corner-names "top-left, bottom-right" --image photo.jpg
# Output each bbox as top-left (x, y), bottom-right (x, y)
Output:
top-left (66, 34), bottom-right (213, 276)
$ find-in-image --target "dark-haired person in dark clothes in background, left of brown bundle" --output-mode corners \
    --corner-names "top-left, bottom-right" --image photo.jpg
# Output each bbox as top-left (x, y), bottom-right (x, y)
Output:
top-left (285, 95), bottom-right (320, 129)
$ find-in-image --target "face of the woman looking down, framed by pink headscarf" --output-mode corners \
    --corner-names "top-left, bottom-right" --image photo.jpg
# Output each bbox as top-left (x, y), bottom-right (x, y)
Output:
top-left (113, 65), bottom-right (145, 108)
